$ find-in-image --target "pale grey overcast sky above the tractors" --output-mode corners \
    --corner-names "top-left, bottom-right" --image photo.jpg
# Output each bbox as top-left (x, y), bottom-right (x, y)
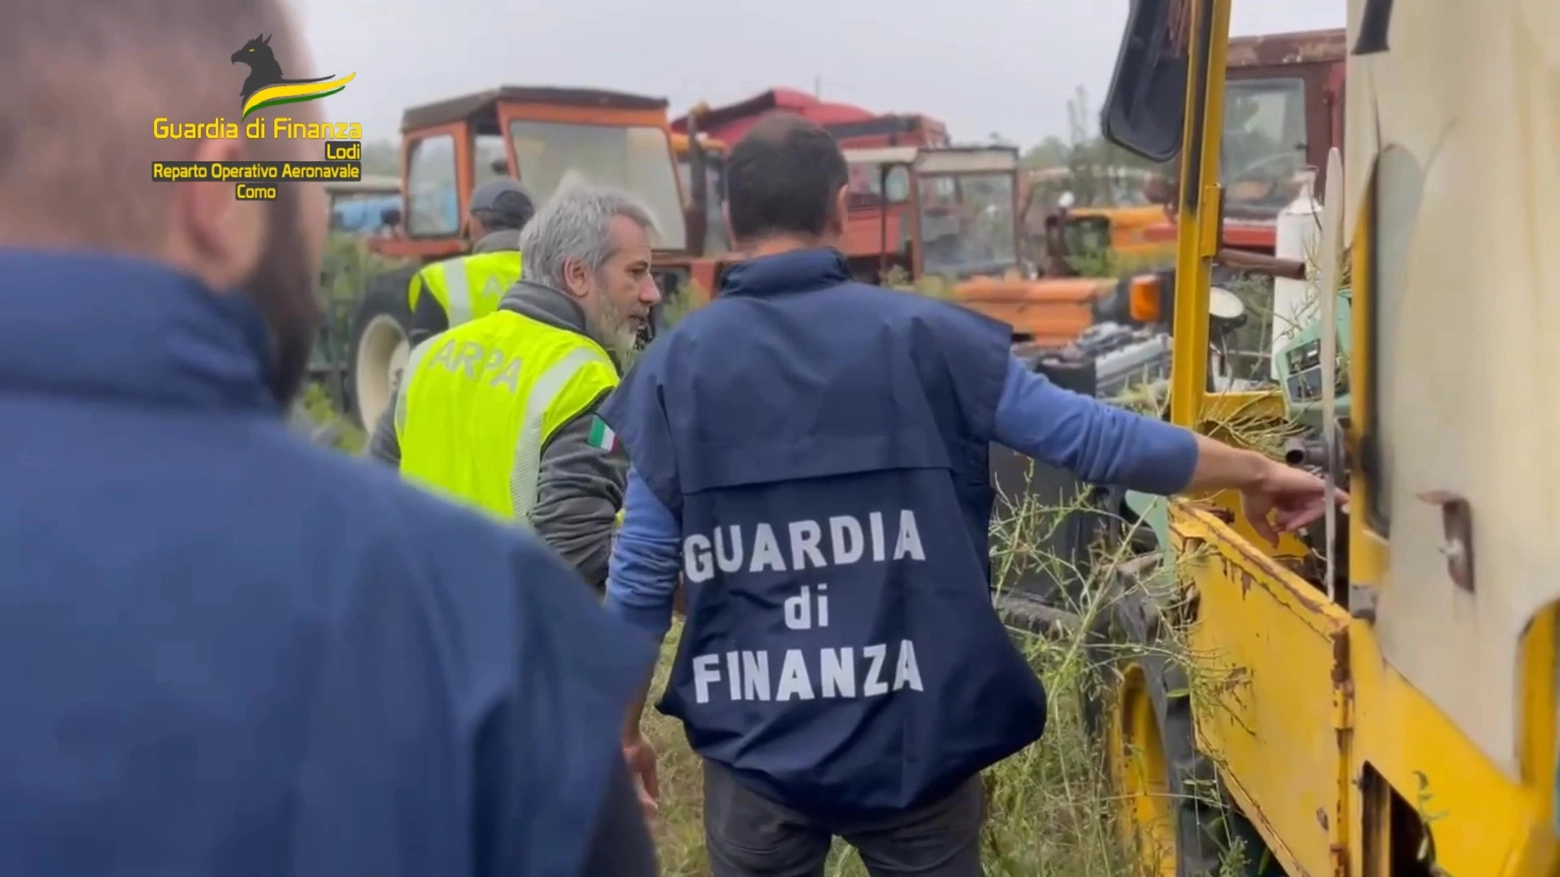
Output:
top-left (292, 0), bottom-right (1345, 145)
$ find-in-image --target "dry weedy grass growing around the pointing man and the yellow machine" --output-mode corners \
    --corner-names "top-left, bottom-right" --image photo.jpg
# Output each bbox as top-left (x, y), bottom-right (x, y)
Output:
top-left (627, 365), bottom-right (1293, 877)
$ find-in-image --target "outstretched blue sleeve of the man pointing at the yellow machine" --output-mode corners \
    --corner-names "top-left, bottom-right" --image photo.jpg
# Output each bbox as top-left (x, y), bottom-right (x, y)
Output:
top-left (992, 356), bottom-right (1197, 496)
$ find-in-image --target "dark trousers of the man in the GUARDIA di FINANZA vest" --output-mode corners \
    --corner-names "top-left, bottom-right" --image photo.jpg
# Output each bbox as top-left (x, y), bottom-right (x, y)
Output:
top-left (704, 760), bottom-right (986, 877)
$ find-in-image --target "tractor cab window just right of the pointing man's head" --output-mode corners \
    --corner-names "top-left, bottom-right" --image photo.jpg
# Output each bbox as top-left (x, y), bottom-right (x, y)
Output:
top-left (919, 173), bottom-right (1019, 278)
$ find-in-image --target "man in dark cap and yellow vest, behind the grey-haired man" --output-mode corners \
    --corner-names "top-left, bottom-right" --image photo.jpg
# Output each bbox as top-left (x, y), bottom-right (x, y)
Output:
top-left (368, 176), bottom-right (537, 465)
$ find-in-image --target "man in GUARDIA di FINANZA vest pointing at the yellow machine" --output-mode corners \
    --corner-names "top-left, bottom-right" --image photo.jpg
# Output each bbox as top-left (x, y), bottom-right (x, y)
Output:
top-left (601, 115), bottom-right (1341, 877)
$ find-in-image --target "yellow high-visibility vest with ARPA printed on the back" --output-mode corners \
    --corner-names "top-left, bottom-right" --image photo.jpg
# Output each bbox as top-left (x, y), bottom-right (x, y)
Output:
top-left (395, 311), bottom-right (618, 524)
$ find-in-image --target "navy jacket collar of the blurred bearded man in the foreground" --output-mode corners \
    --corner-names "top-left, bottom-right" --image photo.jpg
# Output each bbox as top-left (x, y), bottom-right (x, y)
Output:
top-left (0, 248), bottom-right (281, 414)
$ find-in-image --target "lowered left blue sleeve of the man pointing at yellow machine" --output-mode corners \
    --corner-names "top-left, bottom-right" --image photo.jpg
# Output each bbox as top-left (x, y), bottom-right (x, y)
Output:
top-left (607, 468), bottom-right (682, 643)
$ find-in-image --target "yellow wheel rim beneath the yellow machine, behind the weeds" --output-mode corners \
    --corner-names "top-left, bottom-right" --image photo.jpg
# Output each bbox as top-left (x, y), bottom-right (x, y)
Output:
top-left (1106, 663), bottom-right (1176, 877)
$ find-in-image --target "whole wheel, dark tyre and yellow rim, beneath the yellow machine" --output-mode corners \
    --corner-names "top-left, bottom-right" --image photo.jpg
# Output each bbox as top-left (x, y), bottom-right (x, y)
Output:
top-left (1084, 554), bottom-right (1229, 877)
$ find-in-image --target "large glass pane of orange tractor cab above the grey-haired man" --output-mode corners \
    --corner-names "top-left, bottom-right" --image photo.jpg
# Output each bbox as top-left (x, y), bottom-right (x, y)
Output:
top-left (509, 119), bottom-right (688, 250)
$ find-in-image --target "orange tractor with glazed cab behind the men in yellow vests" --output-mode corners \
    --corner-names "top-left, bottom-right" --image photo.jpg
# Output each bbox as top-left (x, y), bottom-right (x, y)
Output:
top-left (345, 86), bottom-right (730, 426)
